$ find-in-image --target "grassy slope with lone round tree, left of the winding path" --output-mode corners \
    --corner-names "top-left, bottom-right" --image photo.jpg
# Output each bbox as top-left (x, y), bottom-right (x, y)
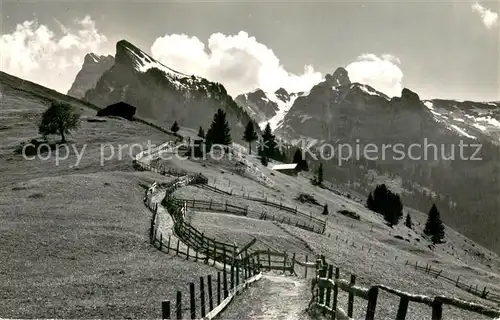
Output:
top-left (0, 73), bottom-right (219, 319)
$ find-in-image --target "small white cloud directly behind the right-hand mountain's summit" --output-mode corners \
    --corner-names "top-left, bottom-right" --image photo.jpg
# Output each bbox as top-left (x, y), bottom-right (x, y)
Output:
top-left (346, 53), bottom-right (403, 97)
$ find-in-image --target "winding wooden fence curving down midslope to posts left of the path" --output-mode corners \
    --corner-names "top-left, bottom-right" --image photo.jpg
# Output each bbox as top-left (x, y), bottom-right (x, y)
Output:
top-left (141, 161), bottom-right (295, 319)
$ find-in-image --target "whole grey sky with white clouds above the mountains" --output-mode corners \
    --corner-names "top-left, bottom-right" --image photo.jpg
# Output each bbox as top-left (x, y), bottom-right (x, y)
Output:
top-left (0, 0), bottom-right (500, 101)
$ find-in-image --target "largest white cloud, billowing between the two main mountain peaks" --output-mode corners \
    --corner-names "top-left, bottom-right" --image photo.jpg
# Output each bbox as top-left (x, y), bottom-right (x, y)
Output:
top-left (151, 31), bottom-right (323, 95)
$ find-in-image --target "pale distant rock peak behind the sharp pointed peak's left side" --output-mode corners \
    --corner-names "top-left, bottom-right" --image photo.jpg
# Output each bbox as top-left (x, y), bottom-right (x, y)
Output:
top-left (68, 53), bottom-right (115, 99)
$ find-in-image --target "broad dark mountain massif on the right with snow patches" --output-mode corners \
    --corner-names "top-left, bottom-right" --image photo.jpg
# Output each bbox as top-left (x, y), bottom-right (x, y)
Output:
top-left (276, 68), bottom-right (500, 252)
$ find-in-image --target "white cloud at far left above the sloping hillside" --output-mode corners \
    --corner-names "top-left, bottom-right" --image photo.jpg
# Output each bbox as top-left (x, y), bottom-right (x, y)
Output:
top-left (0, 16), bottom-right (107, 93)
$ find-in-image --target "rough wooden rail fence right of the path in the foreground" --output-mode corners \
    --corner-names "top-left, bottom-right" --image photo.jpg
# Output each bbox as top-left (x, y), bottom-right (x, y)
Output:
top-left (310, 256), bottom-right (500, 320)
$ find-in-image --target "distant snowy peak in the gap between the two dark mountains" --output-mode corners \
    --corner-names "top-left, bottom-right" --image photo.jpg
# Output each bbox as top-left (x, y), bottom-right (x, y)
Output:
top-left (235, 88), bottom-right (307, 130)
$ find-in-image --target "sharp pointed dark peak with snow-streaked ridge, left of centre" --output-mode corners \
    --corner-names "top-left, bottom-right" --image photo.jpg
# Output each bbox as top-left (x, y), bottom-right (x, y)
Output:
top-left (85, 40), bottom-right (258, 141)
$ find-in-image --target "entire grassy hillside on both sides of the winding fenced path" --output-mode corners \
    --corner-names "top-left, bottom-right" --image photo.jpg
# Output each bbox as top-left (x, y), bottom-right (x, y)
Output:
top-left (0, 71), bottom-right (500, 320)
